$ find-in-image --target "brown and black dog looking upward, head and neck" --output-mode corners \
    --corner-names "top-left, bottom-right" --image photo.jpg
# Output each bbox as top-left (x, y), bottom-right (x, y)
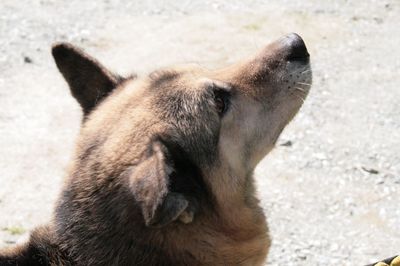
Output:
top-left (0, 33), bottom-right (312, 266)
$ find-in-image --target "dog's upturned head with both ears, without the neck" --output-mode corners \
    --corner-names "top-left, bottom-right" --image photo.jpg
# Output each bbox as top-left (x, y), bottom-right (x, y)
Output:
top-left (53, 34), bottom-right (311, 226)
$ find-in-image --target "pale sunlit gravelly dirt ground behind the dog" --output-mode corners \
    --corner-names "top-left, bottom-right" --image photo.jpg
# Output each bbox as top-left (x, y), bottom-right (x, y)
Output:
top-left (0, 0), bottom-right (400, 266)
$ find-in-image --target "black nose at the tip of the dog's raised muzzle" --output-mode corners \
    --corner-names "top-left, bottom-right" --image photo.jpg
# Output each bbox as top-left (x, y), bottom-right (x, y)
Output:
top-left (283, 33), bottom-right (310, 62)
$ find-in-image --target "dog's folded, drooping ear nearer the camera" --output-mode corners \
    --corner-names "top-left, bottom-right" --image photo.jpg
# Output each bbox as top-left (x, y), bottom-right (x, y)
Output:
top-left (129, 141), bottom-right (193, 227)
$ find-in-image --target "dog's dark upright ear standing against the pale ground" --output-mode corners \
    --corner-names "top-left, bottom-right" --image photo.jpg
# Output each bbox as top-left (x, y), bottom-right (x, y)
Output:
top-left (52, 43), bottom-right (122, 115)
